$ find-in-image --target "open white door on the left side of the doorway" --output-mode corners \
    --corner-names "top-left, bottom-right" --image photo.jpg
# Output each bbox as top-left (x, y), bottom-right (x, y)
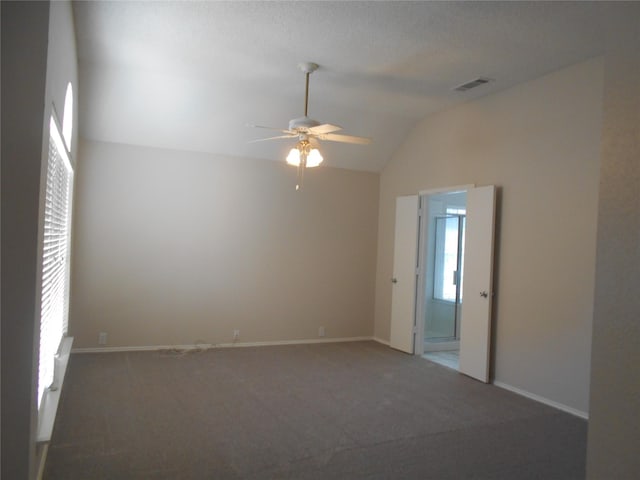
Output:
top-left (389, 195), bottom-right (419, 353)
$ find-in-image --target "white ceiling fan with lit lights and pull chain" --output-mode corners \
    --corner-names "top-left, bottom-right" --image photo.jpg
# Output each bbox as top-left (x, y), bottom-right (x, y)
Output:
top-left (251, 62), bottom-right (371, 190)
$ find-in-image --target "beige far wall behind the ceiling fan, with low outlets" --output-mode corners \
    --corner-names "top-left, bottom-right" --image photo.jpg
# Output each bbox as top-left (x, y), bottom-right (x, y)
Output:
top-left (70, 142), bottom-right (379, 348)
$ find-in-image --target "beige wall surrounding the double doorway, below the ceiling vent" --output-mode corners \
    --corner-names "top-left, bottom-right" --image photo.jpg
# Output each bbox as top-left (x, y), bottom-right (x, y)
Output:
top-left (375, 59), bottom-right (603, 412)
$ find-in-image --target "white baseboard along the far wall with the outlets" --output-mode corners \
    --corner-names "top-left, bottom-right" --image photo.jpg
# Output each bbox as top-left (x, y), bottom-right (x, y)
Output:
top-left (71, 337), bottom-right (382, 353)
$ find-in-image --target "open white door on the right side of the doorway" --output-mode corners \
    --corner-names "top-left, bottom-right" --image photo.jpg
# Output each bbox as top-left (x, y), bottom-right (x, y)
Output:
top-left (459, 185), bottom-right (496, 383)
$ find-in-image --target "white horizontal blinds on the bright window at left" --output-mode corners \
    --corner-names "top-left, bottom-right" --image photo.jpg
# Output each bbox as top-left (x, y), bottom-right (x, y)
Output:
top-left (38, 117), bottom-right (73, 408)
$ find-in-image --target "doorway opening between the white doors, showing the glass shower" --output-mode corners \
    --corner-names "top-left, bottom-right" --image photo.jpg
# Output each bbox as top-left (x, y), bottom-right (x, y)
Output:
top-left (417, 191), bottom-right (467, 370)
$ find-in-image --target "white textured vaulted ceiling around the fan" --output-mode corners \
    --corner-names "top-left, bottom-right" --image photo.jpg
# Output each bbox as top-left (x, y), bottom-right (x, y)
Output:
top-left (74, 1), bottom-right (637, 171)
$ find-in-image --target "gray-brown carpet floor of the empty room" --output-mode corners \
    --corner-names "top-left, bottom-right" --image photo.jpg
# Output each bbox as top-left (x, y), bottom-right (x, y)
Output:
top-left (44, 342), bottom-right (587, 480)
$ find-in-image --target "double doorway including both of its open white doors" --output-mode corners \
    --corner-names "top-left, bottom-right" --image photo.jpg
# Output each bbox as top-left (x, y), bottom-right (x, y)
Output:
top-left (389, 185), bottom-right (496, 383)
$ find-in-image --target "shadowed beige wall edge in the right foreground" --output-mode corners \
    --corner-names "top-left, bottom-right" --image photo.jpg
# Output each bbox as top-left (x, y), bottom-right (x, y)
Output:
top-left (587, 12), bottom-right (640, 480)
